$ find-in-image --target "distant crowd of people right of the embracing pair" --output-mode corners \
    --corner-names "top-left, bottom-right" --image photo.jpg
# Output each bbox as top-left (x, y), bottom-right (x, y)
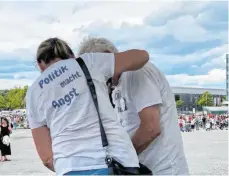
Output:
top-left (178, 114), bottom-right (229, 132)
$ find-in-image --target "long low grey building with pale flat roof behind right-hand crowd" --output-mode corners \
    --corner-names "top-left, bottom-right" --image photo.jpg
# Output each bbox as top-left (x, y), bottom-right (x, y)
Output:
top-left (172, 87), bottom-right (226, 111)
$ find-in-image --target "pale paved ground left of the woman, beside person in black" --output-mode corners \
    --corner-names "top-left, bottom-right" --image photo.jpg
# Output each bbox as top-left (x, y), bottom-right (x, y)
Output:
top-left (0, 129), bottom-right (52, 175)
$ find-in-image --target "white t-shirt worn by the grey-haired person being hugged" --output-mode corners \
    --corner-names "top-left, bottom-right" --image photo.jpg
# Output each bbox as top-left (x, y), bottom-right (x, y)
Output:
top-left (112, 62), bottom-right (189, 175)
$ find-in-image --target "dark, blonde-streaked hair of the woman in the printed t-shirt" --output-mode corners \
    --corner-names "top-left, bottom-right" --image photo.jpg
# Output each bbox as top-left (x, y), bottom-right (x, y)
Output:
top-left (37, 38), bottom-right (74, 64)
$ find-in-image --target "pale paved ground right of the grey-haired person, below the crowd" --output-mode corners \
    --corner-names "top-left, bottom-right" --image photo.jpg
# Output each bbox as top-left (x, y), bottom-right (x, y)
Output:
top-left (183, 131), bottom-right (228, 175)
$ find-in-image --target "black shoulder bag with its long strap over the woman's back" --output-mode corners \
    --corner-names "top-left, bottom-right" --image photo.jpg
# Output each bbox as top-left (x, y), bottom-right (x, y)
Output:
top-left (76, 58), bottom-right (152, 175)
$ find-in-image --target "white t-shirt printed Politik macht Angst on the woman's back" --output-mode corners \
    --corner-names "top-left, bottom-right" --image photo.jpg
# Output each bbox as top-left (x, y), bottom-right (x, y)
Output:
top-left (26, 53), bottom-right (139, 175)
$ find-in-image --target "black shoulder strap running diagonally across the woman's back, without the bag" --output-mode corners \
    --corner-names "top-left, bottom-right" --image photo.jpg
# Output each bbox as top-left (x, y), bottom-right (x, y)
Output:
top-left (76, 57), bottom-right (108, 147)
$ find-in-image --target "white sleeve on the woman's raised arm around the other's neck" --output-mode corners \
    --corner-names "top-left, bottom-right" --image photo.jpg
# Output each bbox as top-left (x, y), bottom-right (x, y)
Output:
top-left (80, 53), bottom-right (115, 81)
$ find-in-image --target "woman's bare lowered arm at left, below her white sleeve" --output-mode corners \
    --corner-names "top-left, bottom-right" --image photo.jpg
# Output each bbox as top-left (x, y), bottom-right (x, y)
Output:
top-left (32, 126), bottom-right (55, 172)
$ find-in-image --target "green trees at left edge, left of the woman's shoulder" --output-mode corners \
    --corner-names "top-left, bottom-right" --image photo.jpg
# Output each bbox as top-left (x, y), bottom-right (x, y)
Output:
top-left (0, 86), bottom-right (28, 110)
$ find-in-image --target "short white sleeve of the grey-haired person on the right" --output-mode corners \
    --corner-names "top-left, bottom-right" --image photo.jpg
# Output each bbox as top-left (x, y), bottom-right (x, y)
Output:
top-left (128, 69), bottom-right (162, 113)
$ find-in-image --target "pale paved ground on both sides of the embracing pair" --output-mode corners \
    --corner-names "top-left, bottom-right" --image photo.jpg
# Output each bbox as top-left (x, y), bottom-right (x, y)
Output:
top-left (0, 130), bottom-right (228, 175)
